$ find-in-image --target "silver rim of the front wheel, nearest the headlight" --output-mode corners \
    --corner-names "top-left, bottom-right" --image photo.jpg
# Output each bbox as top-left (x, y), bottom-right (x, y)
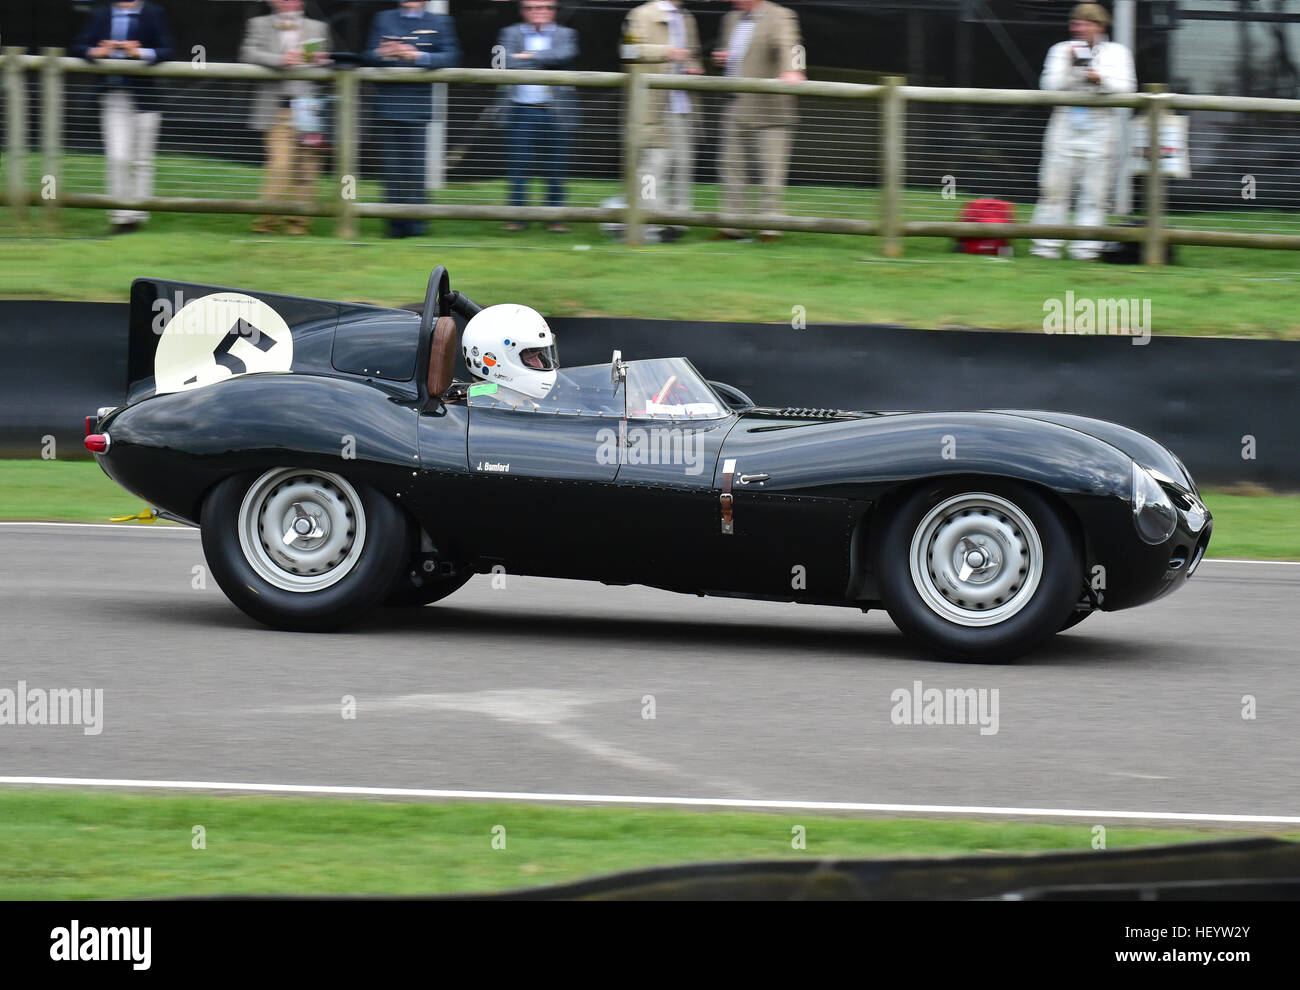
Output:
top-left (909, 492), bottom-right (1043, 626)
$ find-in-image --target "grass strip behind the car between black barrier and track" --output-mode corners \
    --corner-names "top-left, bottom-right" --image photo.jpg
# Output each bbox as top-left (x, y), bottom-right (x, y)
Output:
top-left (0, 460), bottom-right (1300, 560)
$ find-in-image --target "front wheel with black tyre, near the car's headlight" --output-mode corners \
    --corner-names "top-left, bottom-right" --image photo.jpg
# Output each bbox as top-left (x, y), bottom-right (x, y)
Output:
top-left (874, 481), bottom-right (1083, 661)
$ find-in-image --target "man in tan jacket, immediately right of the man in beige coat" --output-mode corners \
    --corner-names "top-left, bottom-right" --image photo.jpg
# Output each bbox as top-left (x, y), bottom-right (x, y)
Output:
top-left (714, 0), bottom-right (807, 240)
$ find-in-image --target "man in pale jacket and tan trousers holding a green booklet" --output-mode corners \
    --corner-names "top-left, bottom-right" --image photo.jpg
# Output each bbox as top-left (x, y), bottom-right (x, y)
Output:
top-left (239, 0), bottom-right (332, 234)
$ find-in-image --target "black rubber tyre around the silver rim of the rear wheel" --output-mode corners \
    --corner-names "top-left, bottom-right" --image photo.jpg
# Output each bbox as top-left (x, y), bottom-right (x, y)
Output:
top-left (200, 469), bottom-right (415, 633)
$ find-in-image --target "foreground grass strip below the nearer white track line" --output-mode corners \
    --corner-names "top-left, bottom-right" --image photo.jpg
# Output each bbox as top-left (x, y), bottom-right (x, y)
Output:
top-left (0, 790), bottom-right (1268, 900)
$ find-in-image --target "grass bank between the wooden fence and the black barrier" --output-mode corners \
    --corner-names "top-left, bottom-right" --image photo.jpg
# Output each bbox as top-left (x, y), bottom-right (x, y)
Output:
top-left (0, 183), bottom-right (1300, 339)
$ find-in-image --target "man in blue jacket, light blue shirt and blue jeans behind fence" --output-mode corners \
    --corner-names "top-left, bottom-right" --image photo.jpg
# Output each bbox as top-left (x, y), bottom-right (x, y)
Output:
top-left (497, 0), bottom-right (577, 234)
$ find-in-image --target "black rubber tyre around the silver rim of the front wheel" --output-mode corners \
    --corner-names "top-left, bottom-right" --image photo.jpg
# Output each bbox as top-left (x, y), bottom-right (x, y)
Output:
top-left (872, 478), bottom-right (1083, 663)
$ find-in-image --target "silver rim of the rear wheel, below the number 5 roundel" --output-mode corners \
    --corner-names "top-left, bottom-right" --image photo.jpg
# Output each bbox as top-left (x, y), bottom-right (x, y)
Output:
top-left (238, 468), bottom-right (365, 594)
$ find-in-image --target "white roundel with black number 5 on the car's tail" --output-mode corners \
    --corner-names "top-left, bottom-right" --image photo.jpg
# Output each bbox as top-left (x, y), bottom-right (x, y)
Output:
top-left (153, 292), bottom-right (294, 392)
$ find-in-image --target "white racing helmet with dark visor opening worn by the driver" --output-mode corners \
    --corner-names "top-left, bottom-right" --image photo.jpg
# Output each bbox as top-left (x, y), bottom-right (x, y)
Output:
top-left (460, 303), bottom-right (559, 399)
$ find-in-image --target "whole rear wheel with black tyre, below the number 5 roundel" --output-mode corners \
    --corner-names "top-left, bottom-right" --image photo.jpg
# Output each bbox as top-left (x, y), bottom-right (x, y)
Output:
top-left (200, 468), bottom-right (412, 631)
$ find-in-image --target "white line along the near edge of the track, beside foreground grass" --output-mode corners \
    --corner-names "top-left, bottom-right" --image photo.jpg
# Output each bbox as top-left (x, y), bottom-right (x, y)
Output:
top-left (0, 777), bottom-right (1300, 825)
